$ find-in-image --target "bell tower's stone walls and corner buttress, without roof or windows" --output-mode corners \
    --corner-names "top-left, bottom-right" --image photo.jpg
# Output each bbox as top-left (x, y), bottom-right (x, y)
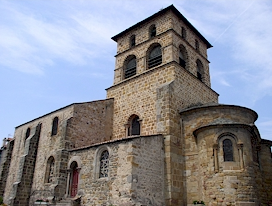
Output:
top-left (107, 9), bottom-right (218, 205)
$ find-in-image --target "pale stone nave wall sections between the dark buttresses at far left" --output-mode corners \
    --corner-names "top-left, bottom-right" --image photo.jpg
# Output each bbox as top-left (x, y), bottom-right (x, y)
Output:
top-left (4, 106), bottom-right (73, 202)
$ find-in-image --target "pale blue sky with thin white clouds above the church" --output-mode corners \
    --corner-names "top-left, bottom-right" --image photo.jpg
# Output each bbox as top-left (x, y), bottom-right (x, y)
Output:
top-left (0, 0), bottom-right (272, 140)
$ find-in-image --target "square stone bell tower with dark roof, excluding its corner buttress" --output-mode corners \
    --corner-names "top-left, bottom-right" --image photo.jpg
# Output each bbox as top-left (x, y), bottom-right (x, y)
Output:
top-left (107, 5), bottom-right (218, 138)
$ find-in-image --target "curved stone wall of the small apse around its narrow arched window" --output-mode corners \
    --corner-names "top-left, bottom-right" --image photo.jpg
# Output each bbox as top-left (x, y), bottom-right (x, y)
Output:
top-left (194, 126), bottom-right (261, 205)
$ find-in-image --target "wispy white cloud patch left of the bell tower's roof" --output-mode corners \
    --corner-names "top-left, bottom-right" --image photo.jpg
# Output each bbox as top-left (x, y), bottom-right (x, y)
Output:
top-left (0, 2), bottom-right (118, 74)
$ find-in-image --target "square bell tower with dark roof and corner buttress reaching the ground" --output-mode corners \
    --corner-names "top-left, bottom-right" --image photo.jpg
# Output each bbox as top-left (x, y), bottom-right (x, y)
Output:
top-left (107, 5), bottom-right (218, 205)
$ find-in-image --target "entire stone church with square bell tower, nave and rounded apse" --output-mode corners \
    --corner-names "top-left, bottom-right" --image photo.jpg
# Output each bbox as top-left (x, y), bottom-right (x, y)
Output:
top-left (0, 5), bottom-right (272, 206)
